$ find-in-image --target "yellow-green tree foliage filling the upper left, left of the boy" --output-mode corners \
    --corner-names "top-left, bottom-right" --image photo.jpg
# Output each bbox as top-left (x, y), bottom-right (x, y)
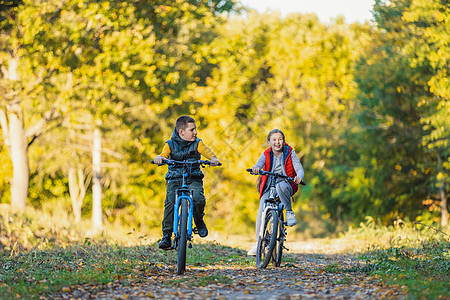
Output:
top-left (1, 0), bottom-right (239, 227)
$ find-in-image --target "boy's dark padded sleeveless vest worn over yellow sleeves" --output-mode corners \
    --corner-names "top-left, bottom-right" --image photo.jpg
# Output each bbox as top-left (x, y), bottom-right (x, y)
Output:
top-left (165, 138), bottom-right (205, 180)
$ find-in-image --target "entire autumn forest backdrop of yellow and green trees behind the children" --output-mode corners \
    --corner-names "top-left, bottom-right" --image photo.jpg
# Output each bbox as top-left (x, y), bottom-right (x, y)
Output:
top-left (0, 0), bottom-right (450, 241)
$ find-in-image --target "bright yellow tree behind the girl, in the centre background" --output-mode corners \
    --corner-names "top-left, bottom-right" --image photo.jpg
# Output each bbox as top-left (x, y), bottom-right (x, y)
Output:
top-left (194, 14), bottom-right (368, 232)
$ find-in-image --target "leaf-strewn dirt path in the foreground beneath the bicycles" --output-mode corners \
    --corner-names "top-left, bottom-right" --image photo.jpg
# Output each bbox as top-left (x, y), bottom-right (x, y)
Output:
top-left (51, 253), bottom-right (406, 300)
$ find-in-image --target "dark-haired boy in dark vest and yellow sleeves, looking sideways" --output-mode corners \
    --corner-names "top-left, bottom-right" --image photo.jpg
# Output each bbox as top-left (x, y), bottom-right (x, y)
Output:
top-left (154, 116), bottom-right (220, 249)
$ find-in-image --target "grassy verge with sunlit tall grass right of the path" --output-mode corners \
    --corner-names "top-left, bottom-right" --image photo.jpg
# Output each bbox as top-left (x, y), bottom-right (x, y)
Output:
top-left (338, 220), bottom-right (450, 299)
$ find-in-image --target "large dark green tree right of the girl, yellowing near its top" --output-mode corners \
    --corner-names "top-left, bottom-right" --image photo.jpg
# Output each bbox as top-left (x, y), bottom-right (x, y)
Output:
top-left (355, 0), bottom-right (448, 226)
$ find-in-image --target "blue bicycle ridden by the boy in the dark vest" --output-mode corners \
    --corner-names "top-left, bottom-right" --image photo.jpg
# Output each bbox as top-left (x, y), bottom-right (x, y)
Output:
top-left (152, 159), bottom-right (222, 275)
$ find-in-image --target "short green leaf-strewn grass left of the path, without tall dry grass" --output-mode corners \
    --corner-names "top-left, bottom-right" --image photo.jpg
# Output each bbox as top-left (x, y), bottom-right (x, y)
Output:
top-left (0, 242), bottom-right (250, 299)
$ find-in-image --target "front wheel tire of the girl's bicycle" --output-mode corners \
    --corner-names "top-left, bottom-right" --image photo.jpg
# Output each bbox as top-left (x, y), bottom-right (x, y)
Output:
top-left (256, 209), bottom-right (278, 269)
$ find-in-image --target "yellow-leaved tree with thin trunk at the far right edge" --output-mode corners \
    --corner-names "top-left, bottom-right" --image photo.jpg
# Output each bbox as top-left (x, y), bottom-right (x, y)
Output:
top-left (402, 0), bottom-right (450, 227)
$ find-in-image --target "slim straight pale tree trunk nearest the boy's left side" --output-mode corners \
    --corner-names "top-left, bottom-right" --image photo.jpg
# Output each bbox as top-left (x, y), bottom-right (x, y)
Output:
top-left (92, 128), bottom-right (102, 230)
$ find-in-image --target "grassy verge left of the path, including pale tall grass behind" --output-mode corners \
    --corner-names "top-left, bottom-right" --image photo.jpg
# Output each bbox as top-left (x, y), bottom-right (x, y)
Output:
top-left (0, 205), bottom-right (254, 299)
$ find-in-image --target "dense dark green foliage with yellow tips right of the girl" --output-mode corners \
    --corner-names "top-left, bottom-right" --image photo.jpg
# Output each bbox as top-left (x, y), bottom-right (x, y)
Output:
top-left (331, 0), bottom-right (448, 226)
